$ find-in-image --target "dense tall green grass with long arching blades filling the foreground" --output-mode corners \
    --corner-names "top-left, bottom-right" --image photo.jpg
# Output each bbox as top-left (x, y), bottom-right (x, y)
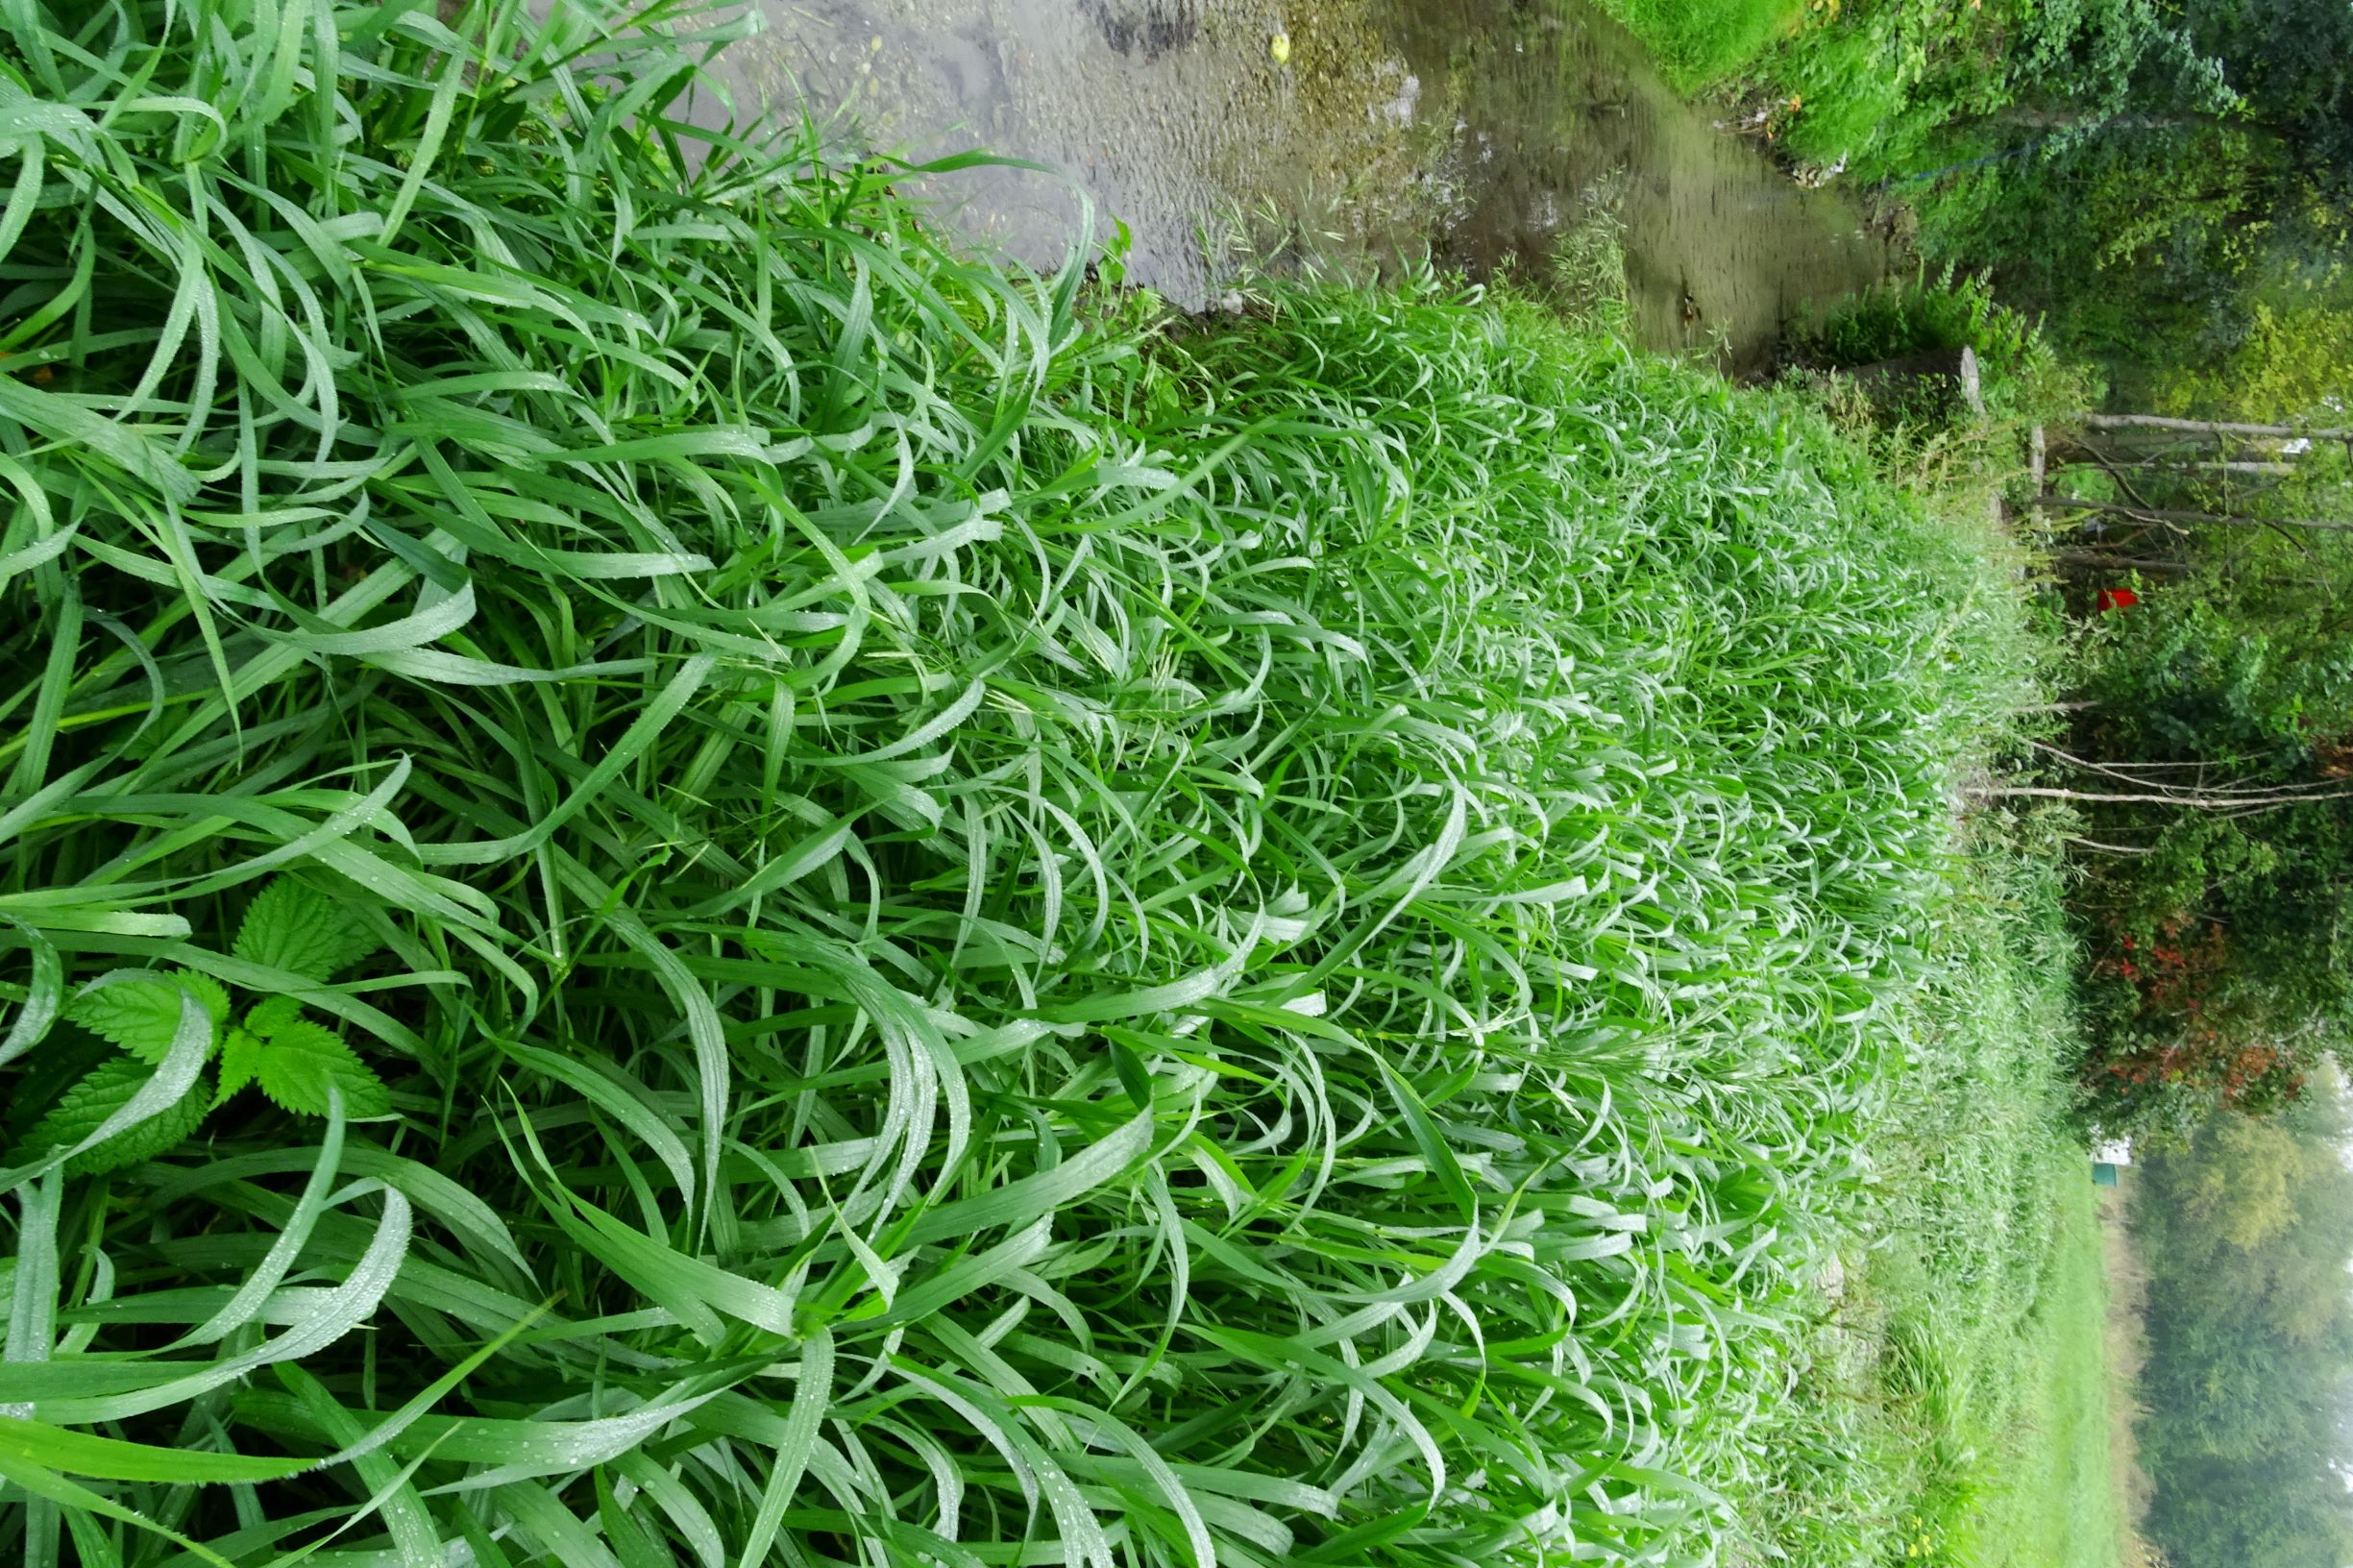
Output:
top-left (0, 0), bottom-right (2012, 1568)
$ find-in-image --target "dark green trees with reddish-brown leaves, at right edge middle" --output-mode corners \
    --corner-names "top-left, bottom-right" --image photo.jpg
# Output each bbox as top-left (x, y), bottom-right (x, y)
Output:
top-left (2054, 438), bottom-right (2353, 1130)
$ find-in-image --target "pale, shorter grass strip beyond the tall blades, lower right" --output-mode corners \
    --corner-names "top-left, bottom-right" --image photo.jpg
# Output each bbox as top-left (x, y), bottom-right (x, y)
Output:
top-left (1755, 838), bottom-right (2120, 1568)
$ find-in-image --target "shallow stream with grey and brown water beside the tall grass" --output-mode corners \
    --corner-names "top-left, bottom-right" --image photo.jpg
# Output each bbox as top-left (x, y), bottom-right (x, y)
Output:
top-left (724, 0), bottom-right (1887, 370)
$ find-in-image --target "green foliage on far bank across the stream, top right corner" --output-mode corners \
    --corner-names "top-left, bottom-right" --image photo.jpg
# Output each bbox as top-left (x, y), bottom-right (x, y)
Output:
top-left (1712, 0), bottom-right (2353, 393)
